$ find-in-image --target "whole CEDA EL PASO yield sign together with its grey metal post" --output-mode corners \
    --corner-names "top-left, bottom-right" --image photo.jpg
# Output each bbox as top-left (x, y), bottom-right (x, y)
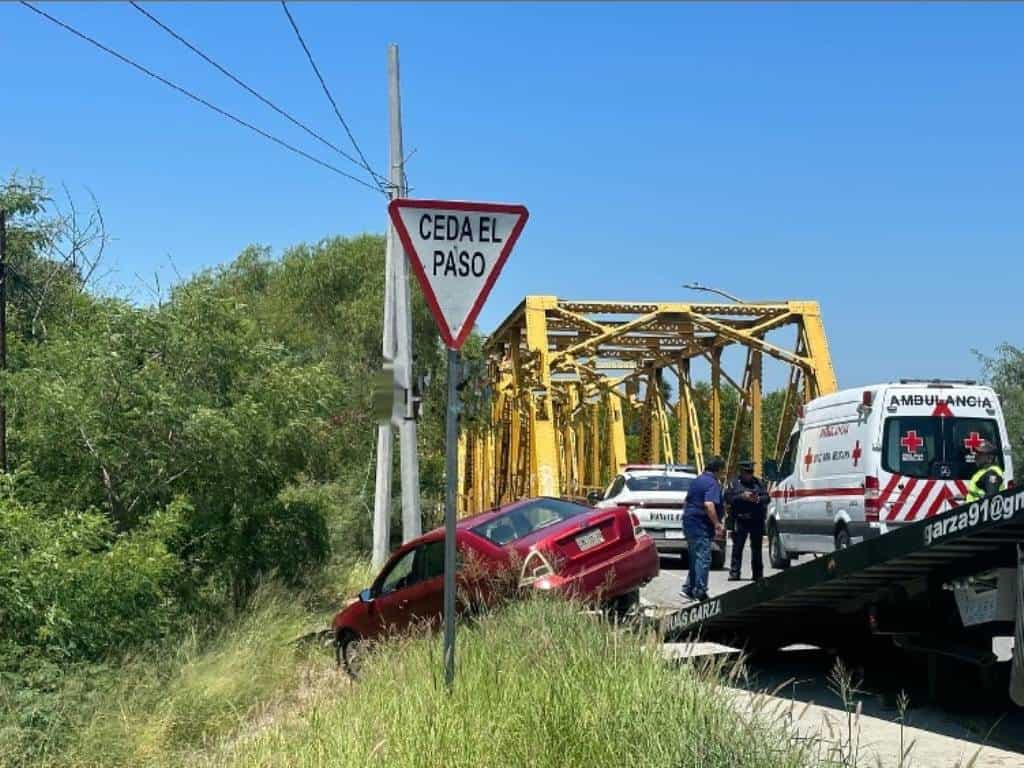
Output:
top-left (388, 199), bottom-right (528, 688)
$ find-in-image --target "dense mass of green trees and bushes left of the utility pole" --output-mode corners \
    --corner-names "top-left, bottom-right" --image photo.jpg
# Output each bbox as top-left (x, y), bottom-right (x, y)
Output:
top-left (0, 179), bottom-right (443, 671)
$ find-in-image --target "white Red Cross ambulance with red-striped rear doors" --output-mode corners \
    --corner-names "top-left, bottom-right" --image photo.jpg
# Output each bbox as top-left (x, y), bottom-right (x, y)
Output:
top-left (765, 379), bottom-right (1013, 568)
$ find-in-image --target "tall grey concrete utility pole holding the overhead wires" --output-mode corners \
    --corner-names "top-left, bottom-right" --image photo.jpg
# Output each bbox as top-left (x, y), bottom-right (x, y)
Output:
top-left (373, 43), bottom-right (422, 567)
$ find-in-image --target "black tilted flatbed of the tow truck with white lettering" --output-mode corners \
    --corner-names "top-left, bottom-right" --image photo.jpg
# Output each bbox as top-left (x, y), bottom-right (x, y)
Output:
top-left (659, 488), bottom-right (1024, 677)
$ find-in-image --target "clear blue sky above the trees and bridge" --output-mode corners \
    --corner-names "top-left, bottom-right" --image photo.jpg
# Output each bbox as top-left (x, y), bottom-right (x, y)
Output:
top-left (0, 3), bottom-right (1024, 386)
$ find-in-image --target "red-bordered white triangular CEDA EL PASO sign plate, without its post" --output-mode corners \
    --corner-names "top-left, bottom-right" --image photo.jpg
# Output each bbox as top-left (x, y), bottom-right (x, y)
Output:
top-left (388, 199), bottom-right (528, 349)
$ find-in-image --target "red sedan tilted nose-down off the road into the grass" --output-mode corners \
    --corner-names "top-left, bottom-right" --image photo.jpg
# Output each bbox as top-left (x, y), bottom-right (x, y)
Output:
top-left (332, 498), bottom-right (657, 674)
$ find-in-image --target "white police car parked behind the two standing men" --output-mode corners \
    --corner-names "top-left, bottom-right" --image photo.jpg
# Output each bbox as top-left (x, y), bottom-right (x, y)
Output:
top-left (589, 464), bottom-right (725, 570)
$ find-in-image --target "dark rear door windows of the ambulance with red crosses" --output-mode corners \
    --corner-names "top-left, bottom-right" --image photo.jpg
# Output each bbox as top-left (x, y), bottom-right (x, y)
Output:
top-left (882, 416), bottom-right (1002, 480)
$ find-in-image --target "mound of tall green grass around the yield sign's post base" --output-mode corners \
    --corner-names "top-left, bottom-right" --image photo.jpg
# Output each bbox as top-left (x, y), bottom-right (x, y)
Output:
top-left (195, 600), bottom-right (805, 768)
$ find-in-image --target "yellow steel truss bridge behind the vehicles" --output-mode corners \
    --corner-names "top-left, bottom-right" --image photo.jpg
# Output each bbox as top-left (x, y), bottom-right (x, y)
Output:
top-left (460, 296), bottom-right (836, 514)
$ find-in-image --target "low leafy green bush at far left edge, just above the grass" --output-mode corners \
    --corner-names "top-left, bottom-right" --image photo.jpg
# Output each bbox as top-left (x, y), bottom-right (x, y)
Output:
top-left (0, 476), bottom-right (187, 660)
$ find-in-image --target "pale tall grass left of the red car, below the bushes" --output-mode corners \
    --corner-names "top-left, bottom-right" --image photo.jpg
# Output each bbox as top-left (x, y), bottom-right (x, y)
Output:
top-left (6, 565), bottom-right (367, 767)
